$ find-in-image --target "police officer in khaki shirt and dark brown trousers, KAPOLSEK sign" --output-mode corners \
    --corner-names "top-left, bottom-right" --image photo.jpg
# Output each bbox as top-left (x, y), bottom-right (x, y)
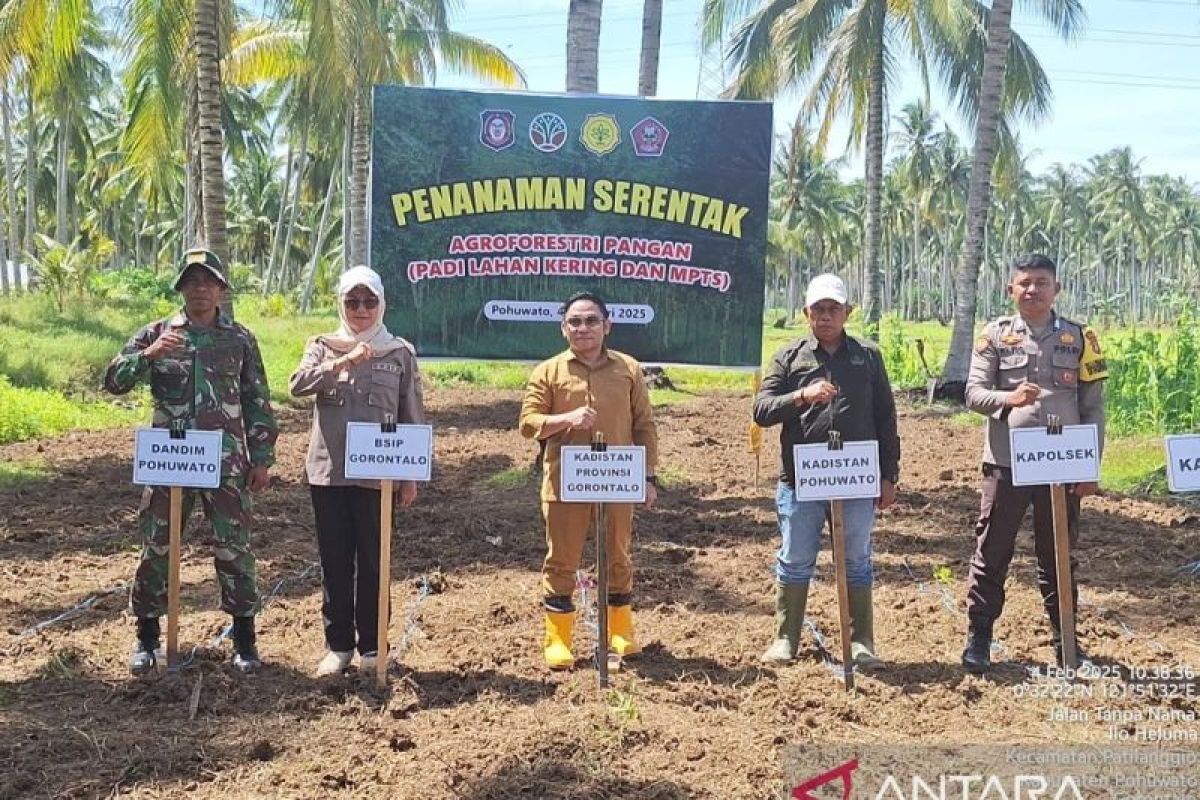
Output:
top-left (962, 254), bottom-right (1108, 674)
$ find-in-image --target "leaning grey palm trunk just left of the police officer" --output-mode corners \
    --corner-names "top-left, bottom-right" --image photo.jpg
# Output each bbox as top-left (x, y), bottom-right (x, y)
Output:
top-left (942, 0), bottom-right (1013, 381)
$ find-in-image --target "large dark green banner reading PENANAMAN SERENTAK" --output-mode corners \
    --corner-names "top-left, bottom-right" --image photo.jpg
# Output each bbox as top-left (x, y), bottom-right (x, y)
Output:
top-left (371, 86), bottom-right (772, 367)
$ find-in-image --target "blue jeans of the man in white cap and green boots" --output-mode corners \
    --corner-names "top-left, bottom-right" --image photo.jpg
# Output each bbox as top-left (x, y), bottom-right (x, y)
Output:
top-left (775, 483), bottom-right (875, 587)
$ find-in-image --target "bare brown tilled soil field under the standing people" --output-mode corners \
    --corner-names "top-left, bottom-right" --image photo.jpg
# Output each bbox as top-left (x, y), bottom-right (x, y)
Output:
top-left (0, 389), bottom-right (1200, 800)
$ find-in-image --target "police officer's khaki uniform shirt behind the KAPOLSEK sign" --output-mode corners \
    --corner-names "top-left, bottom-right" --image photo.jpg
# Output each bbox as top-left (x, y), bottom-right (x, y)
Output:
top-left (966, 314), bottom-right (1108, 467)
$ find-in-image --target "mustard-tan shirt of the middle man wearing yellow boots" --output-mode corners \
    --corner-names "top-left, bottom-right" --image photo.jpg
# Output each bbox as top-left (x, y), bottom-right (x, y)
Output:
top-left (521, 349), bottom-right (659, 501)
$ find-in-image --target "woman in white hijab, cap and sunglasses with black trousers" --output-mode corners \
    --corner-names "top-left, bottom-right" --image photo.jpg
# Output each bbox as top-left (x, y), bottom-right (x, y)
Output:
top-left (289, 266), bottom-right (425, 675)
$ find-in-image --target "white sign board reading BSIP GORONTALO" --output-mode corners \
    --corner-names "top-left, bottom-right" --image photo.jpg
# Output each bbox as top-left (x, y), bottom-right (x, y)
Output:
top-left (346, 422), bottom-right (433, 481)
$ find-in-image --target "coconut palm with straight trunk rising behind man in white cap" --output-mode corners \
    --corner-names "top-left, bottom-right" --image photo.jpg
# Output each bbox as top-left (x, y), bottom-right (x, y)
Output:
top-left (702, 0), bottom-right (1074, 326)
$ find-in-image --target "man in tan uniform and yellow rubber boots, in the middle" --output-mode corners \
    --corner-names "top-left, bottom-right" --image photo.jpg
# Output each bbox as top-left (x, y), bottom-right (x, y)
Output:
top-left (520, 291), bottom-right (658, 669)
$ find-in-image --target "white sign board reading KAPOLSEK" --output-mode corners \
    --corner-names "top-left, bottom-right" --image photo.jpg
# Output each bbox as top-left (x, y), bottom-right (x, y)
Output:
top-left (1008, 425), bottom-right (1100, 486)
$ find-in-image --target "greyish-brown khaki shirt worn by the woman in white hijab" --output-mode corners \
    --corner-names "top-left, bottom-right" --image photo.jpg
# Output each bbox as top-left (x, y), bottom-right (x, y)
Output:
top-left (288, 336), bottom-right (425, 489)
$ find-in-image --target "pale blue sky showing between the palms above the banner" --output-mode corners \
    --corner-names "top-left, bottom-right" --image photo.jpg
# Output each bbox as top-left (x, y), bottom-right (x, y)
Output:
top-left (437, 0), bottom-right (1200, 184)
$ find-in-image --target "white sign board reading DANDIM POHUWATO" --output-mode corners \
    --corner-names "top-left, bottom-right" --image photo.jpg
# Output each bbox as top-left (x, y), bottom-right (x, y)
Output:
top-left (133, 428), bottom-right (224, 489)
